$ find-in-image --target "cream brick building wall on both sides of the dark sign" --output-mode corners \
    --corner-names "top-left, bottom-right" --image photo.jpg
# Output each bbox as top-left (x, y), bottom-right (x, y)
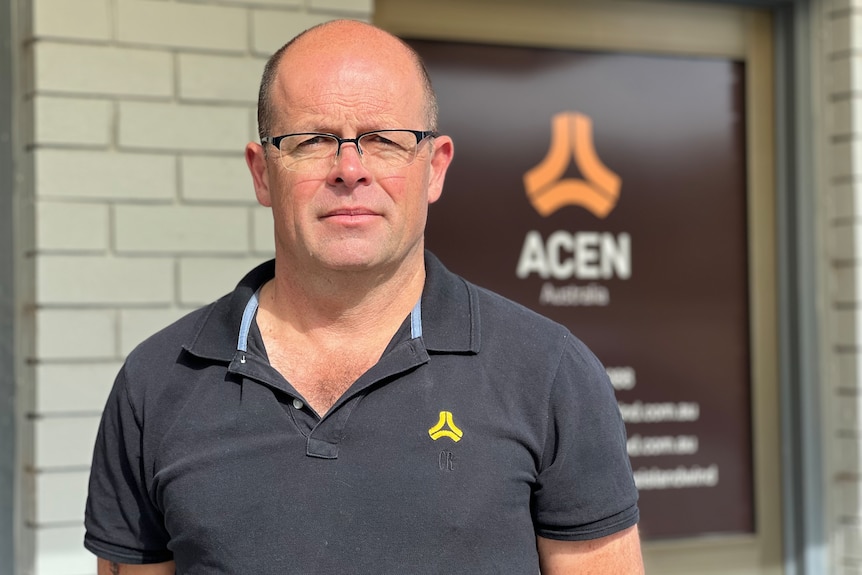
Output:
top-left (13, 0), bottom-right (862, 575)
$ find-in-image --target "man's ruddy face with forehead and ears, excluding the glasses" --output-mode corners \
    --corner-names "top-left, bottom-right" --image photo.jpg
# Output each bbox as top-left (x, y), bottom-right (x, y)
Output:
top-left (250, 28), bottom-right (452, 271)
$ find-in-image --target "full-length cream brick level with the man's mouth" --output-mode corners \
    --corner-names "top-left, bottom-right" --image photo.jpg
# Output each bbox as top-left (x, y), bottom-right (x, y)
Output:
top-left (116, 206), bottom-right (249, 254)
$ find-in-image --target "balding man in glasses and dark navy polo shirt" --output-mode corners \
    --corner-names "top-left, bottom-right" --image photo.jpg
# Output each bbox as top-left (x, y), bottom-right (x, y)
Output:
top-left (85, 21), bottom-right (642, 575)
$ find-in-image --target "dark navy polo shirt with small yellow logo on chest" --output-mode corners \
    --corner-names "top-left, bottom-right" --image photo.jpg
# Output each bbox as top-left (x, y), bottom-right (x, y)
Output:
top-left (85, 253), bottom-right (638, 575)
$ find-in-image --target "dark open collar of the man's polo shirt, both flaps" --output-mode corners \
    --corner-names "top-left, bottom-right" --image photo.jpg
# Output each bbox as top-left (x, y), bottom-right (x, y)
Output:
top-left (183, 251), bottom-right (480, 363)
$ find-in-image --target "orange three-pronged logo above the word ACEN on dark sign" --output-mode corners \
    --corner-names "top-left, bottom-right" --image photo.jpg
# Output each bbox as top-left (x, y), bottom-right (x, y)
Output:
top-left (524, 112), bottom-right (621, 218)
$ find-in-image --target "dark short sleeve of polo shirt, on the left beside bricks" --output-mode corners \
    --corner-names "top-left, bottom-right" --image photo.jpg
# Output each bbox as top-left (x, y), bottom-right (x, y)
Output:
top-left (84, 366), bottom-right (173, 564)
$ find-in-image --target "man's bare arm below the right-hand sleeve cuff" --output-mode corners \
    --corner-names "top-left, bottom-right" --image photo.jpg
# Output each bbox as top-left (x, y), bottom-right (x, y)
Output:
top-left (537, 525), bottom-right (644, 575)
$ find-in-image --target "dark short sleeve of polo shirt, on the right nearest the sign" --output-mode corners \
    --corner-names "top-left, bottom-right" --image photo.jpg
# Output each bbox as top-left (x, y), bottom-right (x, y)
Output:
top-left (534, 335), bottom-right (639, 541)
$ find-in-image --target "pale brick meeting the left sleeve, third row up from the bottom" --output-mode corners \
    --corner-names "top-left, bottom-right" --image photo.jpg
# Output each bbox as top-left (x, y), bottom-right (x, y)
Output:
top-left (34, 416), bottom-right (99, 470)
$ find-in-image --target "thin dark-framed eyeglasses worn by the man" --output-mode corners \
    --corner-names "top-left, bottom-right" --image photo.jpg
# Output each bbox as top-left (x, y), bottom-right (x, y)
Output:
top-left (260, 130), bottom-right (439, 172)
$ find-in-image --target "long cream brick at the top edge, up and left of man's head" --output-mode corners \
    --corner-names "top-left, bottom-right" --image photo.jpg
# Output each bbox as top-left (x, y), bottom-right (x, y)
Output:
top-left (117, 0), bottom-right (248, 51)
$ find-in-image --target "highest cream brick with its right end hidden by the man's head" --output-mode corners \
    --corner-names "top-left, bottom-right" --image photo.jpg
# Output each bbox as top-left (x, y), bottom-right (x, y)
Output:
top-left (178, 54), bottom-right (266, 106)
